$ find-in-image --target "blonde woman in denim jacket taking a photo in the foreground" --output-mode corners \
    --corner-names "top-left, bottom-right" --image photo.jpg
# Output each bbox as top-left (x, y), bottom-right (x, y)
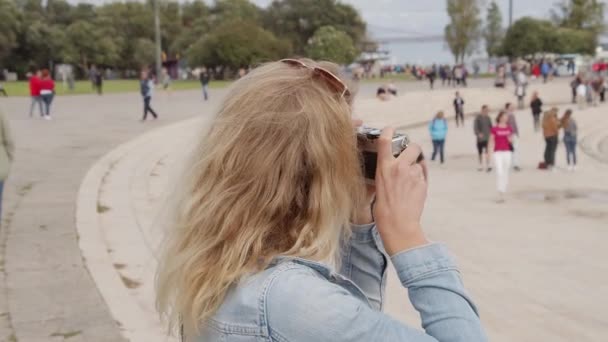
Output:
top-left (157, 59), bottom-right (486, 342)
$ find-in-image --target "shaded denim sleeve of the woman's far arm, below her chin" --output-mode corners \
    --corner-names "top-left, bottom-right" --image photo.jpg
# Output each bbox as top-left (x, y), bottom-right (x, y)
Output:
top-left (340, 223), bottom-right (388, 310)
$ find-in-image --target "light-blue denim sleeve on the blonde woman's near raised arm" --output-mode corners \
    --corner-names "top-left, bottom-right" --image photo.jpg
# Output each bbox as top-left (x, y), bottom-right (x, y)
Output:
top-left (263, 245), bottom-right (487, 342)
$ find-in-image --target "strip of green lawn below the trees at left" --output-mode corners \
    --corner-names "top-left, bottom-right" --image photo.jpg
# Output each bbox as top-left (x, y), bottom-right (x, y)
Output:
top-left (2, 80), bottom-right (230, 96)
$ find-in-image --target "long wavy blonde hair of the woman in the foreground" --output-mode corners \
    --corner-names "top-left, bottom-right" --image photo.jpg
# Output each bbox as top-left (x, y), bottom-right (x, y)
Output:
top-left (156, 60), bottom-right (363, 331)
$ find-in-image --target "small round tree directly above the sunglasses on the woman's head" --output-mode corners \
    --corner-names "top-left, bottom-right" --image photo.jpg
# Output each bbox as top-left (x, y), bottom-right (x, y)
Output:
top-left (306, 26), bottom-right (357, 64)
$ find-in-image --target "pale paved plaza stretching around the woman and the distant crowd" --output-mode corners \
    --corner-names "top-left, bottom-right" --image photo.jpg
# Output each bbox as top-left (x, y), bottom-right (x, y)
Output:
top-left (0, 80), bottom-right (608, 342)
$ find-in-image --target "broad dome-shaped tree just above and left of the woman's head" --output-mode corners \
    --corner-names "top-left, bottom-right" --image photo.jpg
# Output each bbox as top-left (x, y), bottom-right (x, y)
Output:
top-left (187, 20), bottom-right (291, 69)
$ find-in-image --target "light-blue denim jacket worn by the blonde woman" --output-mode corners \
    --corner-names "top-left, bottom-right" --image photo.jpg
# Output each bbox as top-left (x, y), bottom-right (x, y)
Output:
top-left (192, 224), bottom-right (487, 342)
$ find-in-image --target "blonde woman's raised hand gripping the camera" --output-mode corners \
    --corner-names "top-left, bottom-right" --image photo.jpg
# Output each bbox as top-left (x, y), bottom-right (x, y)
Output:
top-left (374, 128), bottom-right (428, 256)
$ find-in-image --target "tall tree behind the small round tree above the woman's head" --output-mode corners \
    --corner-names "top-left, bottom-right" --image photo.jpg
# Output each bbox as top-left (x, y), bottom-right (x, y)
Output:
top-left (264, 0), bottom-right (366, 54)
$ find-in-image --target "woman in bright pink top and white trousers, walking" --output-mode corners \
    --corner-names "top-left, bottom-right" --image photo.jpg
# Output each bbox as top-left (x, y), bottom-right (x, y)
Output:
top-left (490, 111), bottom-right (513, 203)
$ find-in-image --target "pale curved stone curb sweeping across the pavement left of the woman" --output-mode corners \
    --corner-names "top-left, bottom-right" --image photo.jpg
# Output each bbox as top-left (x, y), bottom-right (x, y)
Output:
top-left (76, 118), bottom-right (199, 342)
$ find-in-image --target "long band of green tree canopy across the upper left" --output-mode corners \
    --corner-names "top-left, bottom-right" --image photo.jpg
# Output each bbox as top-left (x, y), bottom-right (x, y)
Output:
top-left (0, 0), bottom-right (366, 76)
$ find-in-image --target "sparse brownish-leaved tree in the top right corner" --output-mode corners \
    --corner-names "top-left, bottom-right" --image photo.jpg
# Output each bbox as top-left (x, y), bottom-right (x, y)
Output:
top-left (551, 0), bottom-right (605, 36)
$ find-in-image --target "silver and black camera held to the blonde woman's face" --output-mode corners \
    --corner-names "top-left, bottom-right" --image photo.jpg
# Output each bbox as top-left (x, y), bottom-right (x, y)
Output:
top-left (357, 126), bottom-right (410, 184)
